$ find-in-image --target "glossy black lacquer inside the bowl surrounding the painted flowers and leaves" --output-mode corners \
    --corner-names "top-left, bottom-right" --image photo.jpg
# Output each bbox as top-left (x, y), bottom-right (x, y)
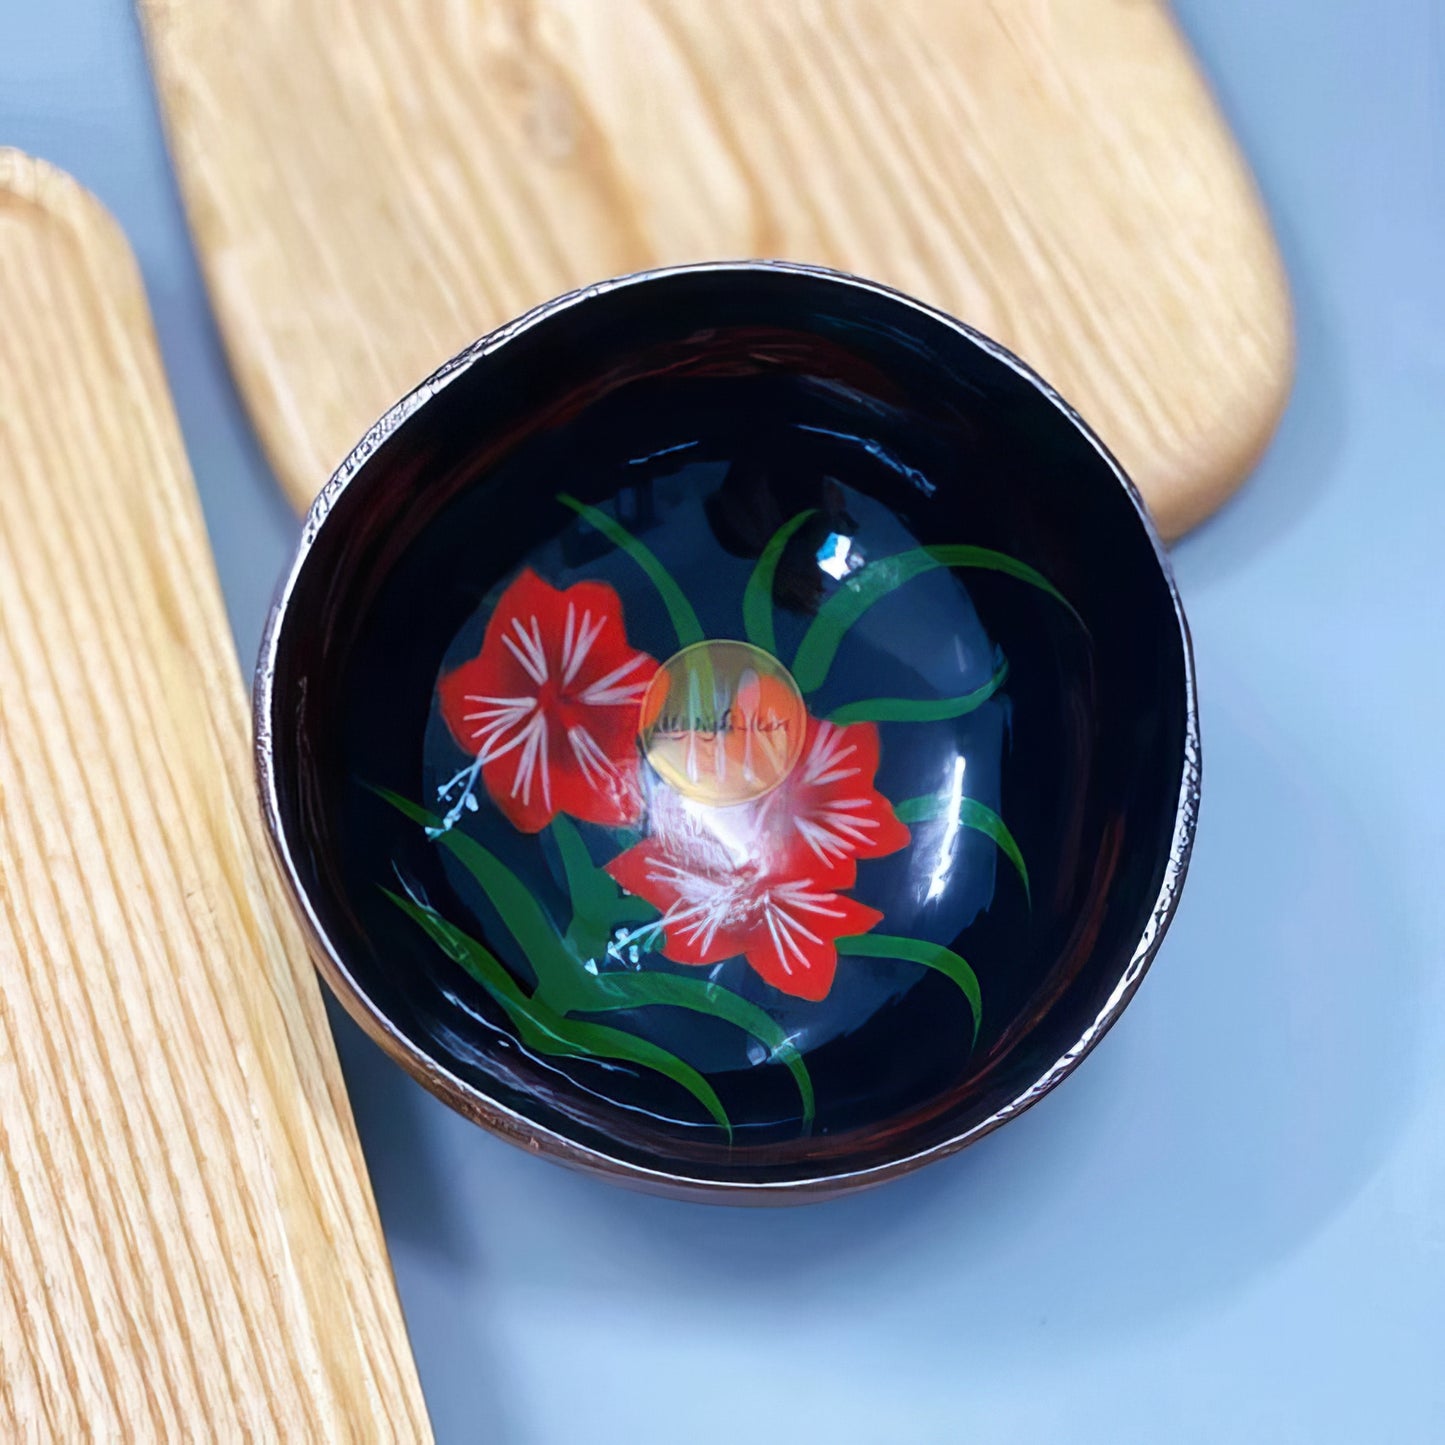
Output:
top-left (270, 267), bottom-right (1189, 1182)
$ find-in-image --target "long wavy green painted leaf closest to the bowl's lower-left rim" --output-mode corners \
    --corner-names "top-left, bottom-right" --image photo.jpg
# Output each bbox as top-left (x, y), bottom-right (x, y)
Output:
top-left (381, 889), bottom-right (733, 1142)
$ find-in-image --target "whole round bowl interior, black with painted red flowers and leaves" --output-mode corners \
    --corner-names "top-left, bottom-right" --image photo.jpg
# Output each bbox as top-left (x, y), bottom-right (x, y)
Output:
top-left (262, 267), bottom-right (1191, 1186)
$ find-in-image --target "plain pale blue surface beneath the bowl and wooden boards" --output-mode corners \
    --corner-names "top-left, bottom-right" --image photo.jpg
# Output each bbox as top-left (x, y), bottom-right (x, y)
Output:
top-left (0, 0), bottom-right (1445, 1445)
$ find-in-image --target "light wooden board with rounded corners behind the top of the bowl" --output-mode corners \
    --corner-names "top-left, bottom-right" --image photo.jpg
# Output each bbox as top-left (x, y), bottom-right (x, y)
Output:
top-left (140, 0), bottom-right (1292, 536)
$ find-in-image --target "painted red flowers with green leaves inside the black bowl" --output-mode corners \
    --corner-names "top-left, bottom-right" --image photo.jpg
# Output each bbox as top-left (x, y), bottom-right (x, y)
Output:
top-left (372, 494), bottom-right (1068, 1137)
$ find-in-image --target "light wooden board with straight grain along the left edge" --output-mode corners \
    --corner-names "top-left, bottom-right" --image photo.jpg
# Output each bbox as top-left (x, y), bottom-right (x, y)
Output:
top-left (0, 152), bottom-right (428, 1442)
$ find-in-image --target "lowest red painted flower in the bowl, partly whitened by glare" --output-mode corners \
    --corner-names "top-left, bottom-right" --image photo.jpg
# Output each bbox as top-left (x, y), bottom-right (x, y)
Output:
top-left (607, 805), bottom-right (883, 1000)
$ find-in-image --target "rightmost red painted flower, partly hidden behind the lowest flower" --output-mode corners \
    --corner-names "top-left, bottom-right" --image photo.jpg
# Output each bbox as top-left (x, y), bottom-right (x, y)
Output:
top-left (759, 717), bottom-right (909, 887)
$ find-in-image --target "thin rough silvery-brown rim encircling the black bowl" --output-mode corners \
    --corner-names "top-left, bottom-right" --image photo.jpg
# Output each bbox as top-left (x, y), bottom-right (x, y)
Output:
top-left (253, 260), bottom-right (1201, 1204)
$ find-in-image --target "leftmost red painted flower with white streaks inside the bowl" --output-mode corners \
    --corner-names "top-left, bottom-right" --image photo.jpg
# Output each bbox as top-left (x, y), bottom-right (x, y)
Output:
top-left (438, 569), bottom-right (657, 832)
